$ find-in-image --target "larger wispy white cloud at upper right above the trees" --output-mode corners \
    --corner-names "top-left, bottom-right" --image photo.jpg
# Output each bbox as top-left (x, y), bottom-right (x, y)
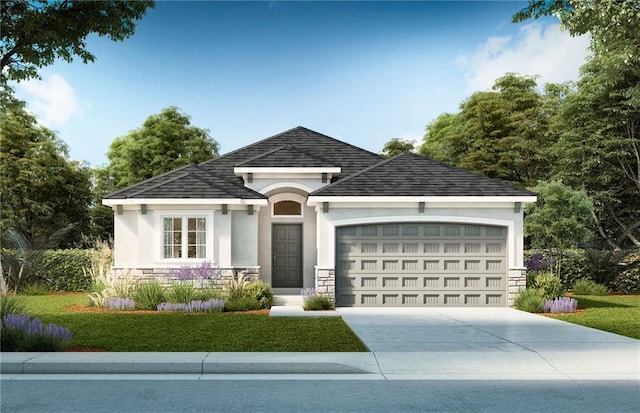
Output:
top-left (456, 23), bottom-right (589, 93)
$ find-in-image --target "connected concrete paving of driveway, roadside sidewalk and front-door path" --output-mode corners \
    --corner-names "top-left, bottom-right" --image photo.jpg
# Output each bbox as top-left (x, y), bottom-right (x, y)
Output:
top-left (0, 308), bottom-right (640, 383)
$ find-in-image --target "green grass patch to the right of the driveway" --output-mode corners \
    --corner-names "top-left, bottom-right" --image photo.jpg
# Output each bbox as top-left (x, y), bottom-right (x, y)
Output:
top-left (553, 295), bottom-right (640, 339)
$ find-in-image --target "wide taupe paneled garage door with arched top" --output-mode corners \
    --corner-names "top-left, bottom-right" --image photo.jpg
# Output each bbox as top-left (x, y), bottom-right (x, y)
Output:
top-left (336, 223), bottom-right (507, 307)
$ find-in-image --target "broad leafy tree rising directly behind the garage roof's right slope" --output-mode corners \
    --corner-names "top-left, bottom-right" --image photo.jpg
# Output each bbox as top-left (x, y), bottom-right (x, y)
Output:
top-left (420, 73), bottom-right (567, 186)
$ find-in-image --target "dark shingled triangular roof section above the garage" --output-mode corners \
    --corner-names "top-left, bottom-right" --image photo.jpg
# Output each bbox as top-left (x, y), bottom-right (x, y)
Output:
top-left (310, 152), bottom-right (535, 197)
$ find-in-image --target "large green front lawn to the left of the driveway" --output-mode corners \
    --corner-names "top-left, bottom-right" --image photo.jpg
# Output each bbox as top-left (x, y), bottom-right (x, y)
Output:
top-left (21, 295), bottom-right (367, 352)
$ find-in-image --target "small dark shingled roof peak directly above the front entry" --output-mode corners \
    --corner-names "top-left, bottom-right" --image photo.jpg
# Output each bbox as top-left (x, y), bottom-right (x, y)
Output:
top-left (235, 145), bottom-right (336, 168)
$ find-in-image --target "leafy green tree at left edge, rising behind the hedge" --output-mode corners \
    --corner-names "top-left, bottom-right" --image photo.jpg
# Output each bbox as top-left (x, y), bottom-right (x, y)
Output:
top-left (0, 100), bottom-right (91, 245)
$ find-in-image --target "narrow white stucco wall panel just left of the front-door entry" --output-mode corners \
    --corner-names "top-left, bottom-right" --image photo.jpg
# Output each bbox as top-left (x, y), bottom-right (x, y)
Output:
top-left (231, 211), bottom-right (258, 267)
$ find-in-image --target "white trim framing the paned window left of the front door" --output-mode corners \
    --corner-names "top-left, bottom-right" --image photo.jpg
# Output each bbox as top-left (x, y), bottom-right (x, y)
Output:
top-left (155, 210), bottom-right (215, 264)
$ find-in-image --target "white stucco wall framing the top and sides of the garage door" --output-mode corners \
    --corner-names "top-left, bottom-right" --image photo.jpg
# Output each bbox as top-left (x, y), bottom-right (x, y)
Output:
top-left (317, 205), bottom-right (523, 268)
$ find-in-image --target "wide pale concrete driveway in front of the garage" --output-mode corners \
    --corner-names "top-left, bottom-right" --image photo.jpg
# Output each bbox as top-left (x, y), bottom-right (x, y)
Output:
top-left (337, 308), bottom-right (640, 380)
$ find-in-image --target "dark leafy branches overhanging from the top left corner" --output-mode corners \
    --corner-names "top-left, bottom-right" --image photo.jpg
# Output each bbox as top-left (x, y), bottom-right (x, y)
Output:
top-left (0, 0), bottom-right (155, 84)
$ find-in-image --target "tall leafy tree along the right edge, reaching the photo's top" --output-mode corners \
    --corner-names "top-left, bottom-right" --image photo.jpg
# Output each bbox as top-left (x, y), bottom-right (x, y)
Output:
top-left (514, 0), bottom-right (640, 248)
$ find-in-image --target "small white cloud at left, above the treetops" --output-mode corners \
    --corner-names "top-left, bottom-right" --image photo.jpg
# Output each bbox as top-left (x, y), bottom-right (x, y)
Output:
top-left (19, 73), bottom-right (81, 127)
